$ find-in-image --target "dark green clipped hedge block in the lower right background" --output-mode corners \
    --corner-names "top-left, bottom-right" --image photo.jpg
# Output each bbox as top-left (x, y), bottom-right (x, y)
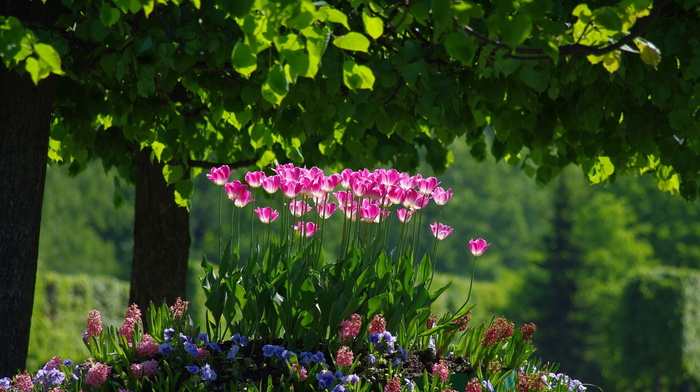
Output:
top-left (616, 267), bottom-right (700, 390)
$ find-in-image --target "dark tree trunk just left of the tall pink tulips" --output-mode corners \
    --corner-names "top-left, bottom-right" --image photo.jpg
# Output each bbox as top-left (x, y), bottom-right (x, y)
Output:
top-left (129, 149), bottom-right (190, 316)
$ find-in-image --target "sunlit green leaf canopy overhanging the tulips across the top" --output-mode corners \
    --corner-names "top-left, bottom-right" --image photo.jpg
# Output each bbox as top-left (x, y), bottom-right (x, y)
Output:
top-left (0, 0), bottom-right (700, 198)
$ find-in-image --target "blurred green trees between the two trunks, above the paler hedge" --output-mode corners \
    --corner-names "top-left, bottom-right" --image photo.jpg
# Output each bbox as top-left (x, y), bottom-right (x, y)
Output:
top-left (39, 165), bottom-right (133, 279)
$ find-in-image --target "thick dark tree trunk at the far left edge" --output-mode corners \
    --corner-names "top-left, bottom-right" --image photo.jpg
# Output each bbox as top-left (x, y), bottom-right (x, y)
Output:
top-left (0, 0), bottom-right (56, 377)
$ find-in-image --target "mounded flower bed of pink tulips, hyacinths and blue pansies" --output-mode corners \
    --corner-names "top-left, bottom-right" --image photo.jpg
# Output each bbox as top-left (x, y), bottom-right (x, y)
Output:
top-left (0, 165), bottom-right (585, 392)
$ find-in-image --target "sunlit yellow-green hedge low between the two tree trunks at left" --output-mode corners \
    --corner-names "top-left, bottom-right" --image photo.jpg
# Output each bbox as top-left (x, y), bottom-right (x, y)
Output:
top-left (27, 271), bottom-right (129, 369)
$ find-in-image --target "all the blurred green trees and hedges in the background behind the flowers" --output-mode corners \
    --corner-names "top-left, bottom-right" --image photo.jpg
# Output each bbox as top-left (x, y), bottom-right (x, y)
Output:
top-left (32, 142), bottom-right (700, 391)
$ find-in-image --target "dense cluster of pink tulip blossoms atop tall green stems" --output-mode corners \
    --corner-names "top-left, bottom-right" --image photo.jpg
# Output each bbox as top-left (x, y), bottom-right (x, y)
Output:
top-left (207, 164), bottom-right (462, 240)
